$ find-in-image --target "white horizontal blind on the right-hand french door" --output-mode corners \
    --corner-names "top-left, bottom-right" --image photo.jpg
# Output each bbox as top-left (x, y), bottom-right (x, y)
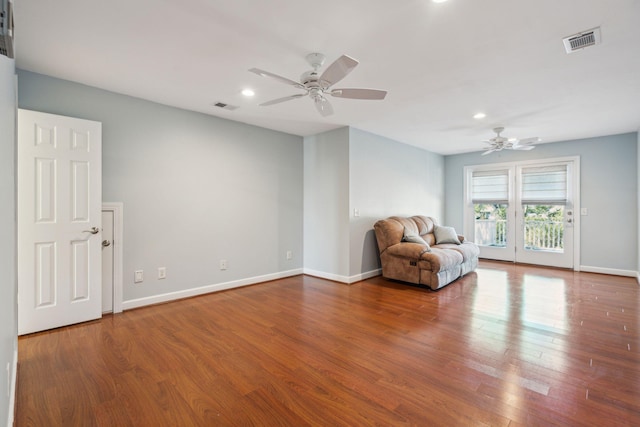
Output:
top-left (522, 165), bottom-right (568, 204)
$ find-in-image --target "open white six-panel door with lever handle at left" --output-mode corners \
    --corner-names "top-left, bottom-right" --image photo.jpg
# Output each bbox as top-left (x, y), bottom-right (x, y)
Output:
top-left (17, 110), bottom-right (102, 335)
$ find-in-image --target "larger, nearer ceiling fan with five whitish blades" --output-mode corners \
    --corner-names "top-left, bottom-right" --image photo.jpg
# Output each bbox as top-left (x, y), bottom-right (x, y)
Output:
top-left (249, 53), bottom-right (387, 117)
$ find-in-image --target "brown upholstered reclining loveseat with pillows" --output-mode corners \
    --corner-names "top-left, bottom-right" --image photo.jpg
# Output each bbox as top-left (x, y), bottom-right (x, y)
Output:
top-left (374, 216), bottom-right (480, 290)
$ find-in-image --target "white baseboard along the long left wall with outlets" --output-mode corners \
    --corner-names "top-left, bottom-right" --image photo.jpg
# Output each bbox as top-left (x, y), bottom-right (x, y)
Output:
top-left (122, 269), bottom-right (303, 310)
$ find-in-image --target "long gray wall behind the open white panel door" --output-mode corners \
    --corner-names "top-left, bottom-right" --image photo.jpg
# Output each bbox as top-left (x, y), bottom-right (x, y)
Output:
top-left (18, 70), bottom-right (303, 301)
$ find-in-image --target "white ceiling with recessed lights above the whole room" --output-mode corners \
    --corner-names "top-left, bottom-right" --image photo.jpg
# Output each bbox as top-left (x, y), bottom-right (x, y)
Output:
top-left (14, 0), bottom-right (640, 154)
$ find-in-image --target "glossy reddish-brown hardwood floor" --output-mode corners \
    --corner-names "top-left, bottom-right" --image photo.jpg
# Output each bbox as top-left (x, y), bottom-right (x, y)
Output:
top-left (16, 261), bottom-right (640, 427)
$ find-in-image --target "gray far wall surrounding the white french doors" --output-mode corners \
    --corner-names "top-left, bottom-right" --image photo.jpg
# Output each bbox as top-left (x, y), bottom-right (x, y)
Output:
top-left (445, 133), bottom-right (638, 271)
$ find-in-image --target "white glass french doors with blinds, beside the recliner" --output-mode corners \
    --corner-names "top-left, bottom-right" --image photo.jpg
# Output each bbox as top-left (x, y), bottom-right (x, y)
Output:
top-left (465, 158), bottom-right (579, 268)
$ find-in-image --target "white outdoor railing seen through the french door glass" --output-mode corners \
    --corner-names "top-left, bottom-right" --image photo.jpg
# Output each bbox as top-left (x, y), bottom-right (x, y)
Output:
top-left (475, 219), bottom-right (564, 251)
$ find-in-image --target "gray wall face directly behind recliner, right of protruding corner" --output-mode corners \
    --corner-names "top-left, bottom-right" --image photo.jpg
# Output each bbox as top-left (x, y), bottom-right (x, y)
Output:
top-left (349, 128), bottom-right (444, 276)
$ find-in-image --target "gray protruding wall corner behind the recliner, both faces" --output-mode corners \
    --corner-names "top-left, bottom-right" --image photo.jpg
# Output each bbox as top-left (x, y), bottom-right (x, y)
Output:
top-left (304, 128), bottom-right (444, 282)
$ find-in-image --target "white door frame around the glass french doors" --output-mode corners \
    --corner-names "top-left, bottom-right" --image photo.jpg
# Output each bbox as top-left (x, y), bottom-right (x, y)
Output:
top-left (463, 156), bottom-right (581, 271)
